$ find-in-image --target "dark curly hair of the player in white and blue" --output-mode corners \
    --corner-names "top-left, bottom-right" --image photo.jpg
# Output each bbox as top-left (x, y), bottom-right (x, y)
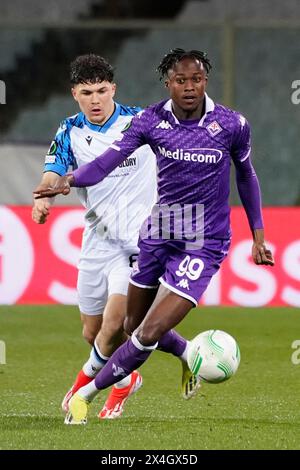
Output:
top-left (70, 54), bottom-right (114, 85)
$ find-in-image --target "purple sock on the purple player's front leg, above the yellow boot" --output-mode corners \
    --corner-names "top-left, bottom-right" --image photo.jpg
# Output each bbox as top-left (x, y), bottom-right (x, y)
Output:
top-left (95, 338), bottom-right (156, 390)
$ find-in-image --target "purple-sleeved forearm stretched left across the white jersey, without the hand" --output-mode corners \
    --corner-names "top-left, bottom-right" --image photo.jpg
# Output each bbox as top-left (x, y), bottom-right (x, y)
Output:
top-left (70, 148), bottom-right (127, 188)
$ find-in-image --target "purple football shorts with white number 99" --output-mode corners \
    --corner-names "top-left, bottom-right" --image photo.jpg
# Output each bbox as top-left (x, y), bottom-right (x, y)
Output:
top-left (130, 239), bottom-right (230, 305)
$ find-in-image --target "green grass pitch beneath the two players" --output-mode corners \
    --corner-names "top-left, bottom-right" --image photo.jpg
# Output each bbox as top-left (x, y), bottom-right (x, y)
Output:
top-left (0, 306), bottom-right (300, 450)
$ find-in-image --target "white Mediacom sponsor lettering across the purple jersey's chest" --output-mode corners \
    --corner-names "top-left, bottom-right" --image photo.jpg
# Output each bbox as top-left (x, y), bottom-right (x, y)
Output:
top-left (158, 146), bottom-right (223, 163)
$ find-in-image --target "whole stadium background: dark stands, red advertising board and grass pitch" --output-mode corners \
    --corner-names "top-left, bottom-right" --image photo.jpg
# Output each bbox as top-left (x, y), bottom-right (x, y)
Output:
top-left (0, 0), bottom-right (300, 449)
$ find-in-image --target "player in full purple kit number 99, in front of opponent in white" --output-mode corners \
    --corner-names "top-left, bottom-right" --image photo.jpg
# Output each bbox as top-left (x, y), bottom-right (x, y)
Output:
top-left (34, 49), bottom-right (274, 424)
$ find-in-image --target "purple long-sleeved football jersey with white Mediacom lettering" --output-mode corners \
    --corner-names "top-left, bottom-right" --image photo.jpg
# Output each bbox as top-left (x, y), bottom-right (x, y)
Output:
top-left (73, 95), bottom-right (263, 244)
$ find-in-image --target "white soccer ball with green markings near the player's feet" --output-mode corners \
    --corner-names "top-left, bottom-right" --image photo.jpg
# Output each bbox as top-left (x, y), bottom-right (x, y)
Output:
top-left (187, 330), bottom-right (241, 383)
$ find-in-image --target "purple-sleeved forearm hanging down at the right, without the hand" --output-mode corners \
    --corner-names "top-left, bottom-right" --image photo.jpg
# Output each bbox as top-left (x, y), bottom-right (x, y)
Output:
top-left (236, 161), bottom-right (263, 233)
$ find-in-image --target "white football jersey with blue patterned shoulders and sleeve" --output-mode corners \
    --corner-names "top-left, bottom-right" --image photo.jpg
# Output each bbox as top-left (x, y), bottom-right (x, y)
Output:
top-left (44, 103), bottom-right (156, 245)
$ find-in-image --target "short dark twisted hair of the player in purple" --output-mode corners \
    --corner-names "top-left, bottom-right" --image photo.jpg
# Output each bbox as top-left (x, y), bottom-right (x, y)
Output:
top-left (157, 48), bottom-right (212, 80)
